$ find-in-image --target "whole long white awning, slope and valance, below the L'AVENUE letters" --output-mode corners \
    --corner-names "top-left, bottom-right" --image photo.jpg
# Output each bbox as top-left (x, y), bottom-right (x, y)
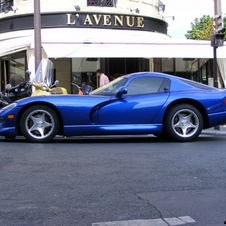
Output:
top-left (42, 29), bottom-right (226, 58)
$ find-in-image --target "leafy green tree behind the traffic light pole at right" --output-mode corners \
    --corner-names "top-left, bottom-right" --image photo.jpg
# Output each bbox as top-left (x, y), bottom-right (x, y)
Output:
top-left (185, 15), bottom-right (226, 40)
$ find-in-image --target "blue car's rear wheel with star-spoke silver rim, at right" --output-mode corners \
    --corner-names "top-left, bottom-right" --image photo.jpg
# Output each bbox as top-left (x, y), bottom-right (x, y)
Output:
top-left (165, 104), bottom-right (203, 142)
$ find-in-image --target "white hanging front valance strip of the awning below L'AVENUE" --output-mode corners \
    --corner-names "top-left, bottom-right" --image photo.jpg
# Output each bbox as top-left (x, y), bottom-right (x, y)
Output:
top-left (42, 42), bottom-right (222, 58)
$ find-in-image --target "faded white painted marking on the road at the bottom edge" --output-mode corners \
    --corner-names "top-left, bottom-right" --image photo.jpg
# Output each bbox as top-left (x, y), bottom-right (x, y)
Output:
top-left (92, 216), bottom-right (196, 226)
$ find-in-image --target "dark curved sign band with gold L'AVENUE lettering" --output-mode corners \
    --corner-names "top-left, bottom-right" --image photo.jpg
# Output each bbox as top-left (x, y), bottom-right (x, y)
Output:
top-left (0, 12), bottom-right (167, 34)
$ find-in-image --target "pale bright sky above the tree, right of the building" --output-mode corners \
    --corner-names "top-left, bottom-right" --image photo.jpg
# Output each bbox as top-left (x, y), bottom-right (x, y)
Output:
top-left (162, 0), bottom-right (226, 39)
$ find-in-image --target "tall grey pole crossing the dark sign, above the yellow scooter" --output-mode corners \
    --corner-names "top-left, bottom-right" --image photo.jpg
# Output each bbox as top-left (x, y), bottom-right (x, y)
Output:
top-left (34, 0), bottom-right (42, 70)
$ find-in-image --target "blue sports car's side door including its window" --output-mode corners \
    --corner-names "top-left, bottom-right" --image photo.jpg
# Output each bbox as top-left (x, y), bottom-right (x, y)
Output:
top-left (97, 76), bottom-right (170, 125)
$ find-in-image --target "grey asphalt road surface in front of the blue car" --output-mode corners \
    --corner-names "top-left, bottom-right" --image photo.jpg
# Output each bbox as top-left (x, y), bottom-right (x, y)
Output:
top-left (0, 134), bottom-right (226, 226)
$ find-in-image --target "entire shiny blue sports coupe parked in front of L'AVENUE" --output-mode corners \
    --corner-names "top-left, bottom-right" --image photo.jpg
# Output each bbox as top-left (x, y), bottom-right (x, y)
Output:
top-left (0, 72), bottom-right (226, 142)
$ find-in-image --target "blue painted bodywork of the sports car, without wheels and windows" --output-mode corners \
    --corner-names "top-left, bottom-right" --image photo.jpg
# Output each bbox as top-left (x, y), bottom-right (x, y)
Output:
top-left (0, 72), bottom-right (226, 139)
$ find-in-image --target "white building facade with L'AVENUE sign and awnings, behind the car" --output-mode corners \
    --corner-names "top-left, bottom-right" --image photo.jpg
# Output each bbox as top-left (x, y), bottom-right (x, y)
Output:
top-left (0, 0), bottom-right (226, 93)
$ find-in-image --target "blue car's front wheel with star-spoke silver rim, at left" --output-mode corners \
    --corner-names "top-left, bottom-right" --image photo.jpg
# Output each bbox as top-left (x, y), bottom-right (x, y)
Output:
top-left (20, 105), bottom-right (59, 143)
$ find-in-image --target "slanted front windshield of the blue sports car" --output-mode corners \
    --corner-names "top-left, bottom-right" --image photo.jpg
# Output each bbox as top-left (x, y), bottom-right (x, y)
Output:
top-left (89, 76), bottom-right (127, 96)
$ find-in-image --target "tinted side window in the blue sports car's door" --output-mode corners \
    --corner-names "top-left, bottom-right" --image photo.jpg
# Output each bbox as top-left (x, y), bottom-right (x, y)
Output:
top-left (127, 77), bottom-right (169, 95)
